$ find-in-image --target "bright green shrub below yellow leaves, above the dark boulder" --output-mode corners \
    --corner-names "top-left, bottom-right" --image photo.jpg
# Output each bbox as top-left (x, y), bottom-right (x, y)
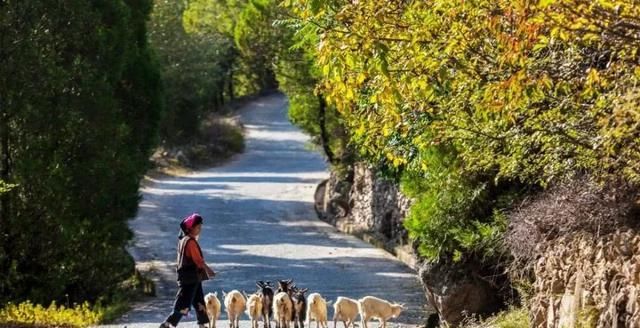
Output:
top-left (401, 149), bottom-right (517, 261)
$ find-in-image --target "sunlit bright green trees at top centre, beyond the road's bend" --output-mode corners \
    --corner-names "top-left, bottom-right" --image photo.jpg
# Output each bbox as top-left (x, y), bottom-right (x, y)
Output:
top-left (184, 0), bottom-right (352, 171)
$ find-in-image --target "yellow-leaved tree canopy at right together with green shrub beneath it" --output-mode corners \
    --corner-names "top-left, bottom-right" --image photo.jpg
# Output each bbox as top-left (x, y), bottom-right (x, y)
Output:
top-left (285, 0), bottom-right (640, 260)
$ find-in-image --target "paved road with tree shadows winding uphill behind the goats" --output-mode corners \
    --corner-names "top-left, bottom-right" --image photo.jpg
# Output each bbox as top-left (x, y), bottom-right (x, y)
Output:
top-left (100, 95), bottom-right (425, 328)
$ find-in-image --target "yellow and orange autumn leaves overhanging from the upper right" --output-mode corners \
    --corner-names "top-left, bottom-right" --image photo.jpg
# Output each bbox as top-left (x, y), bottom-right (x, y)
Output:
top-left (288, 0), bottom-right (640, 181)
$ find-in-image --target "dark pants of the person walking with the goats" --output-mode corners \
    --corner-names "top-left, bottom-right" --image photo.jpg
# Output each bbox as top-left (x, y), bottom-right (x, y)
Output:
top-left (165, 282), bottom-right (209, 326)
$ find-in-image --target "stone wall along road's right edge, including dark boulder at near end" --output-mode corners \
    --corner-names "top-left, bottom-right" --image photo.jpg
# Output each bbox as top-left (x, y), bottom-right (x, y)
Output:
top-left (315, 164), bottom-right (501, 327)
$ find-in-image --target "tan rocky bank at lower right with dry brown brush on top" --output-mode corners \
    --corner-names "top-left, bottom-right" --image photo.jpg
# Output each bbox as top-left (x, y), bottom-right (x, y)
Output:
top-left (505, 176), bottom-right (640, 328)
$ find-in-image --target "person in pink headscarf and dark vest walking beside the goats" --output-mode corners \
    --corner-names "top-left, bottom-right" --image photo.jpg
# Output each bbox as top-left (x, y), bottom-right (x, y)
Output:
top-left (160, 213), bottom-right (215, 328)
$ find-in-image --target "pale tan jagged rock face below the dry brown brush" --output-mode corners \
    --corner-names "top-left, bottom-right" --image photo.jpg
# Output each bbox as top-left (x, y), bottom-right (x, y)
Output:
top-left (531, 230), bottom-right (640, 328)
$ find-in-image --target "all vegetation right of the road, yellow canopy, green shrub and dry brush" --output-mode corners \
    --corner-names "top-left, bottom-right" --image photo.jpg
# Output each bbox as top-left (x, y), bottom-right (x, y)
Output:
top-left (271, 0), bottom-right (640, 326)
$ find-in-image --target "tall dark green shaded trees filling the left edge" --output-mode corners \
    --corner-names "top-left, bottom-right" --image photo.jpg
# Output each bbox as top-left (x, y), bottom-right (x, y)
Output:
top-left (0, 0), bottom-right (162, 303)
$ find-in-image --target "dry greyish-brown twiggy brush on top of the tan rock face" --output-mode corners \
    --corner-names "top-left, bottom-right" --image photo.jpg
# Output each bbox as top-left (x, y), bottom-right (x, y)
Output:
top-left (506, 177), bottom-right (640, 266)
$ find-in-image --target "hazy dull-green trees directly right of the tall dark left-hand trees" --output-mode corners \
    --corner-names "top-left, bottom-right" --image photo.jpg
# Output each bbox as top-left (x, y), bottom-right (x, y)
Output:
top-left (149, 0), bottom-right (235, 145)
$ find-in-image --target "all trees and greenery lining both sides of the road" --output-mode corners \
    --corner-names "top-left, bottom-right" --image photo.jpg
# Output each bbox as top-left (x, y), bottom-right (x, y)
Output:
top-left (0, 0), bottom-right (640, 327)
